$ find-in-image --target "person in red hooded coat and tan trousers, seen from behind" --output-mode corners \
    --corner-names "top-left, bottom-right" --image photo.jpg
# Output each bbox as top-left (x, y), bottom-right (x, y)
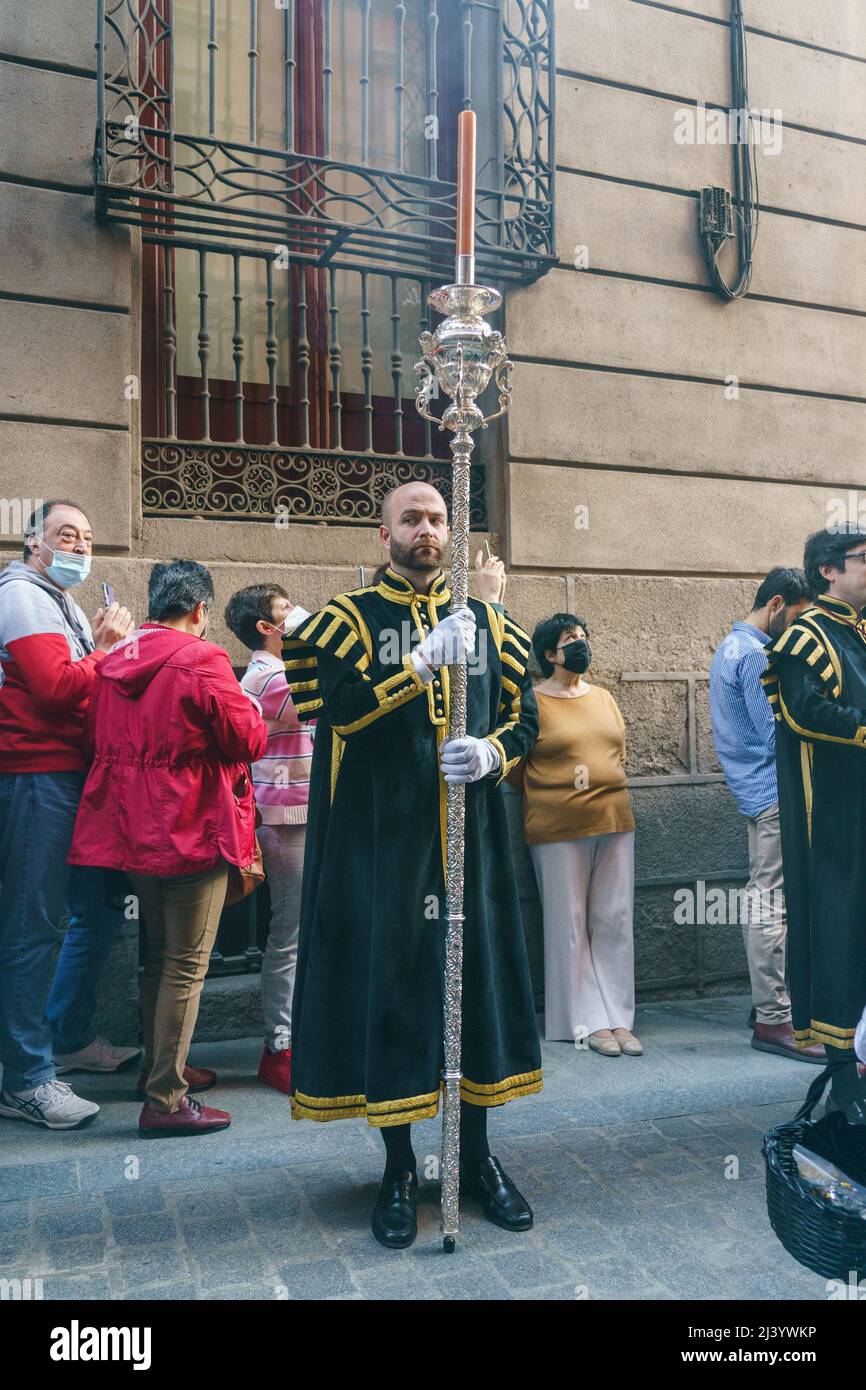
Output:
top-left (70, 560), bottom-right (267, 1136)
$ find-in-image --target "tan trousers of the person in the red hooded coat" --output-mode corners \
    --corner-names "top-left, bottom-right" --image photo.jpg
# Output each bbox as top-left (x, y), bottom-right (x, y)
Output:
top-left (129, 860), bottom-right (228, 1111)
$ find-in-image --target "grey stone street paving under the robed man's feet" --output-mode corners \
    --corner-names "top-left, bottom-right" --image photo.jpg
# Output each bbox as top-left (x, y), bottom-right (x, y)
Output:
top-left (0, 997), bottom-right (827, 1300)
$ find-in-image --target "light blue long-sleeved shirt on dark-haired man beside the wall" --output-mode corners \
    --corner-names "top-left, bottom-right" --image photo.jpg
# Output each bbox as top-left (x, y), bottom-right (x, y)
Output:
top-left (710, 623), bottom-right (778, 816)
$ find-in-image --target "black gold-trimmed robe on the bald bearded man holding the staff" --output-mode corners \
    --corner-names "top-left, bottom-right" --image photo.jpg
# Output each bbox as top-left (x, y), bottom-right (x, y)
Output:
top-left (284, 569), bottom-right (542, 1126)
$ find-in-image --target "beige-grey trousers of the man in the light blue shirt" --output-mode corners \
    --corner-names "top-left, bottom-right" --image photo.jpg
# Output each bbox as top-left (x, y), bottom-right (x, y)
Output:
top-left (742, 802), bottom-right (791, 1024)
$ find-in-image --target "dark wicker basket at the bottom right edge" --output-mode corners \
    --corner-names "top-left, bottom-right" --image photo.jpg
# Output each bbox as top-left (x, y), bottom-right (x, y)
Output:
top-left (762, 1068), bottom-right (866, 1280)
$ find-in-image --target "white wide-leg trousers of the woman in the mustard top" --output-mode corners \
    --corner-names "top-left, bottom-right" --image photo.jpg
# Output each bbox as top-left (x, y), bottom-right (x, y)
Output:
top-left (530, 830), bottom-right (634, 1043)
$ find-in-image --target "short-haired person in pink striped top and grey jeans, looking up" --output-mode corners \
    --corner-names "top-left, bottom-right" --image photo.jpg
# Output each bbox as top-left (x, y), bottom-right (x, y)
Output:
top-left (225, 584), bottom-right (313, 1095)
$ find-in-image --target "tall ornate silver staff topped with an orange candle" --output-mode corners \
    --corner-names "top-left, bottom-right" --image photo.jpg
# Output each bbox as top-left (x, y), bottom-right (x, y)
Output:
top-left (414, 111), bottom-right (512, 1254)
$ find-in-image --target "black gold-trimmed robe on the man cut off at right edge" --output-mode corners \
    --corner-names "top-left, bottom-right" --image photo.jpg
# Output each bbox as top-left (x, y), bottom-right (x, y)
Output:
top-left (762, 595), bottom-right (866, 1048)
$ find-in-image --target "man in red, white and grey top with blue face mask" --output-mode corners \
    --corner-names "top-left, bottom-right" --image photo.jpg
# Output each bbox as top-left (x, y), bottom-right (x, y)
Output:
top-left (0, 500), bottom-right (140, 1129)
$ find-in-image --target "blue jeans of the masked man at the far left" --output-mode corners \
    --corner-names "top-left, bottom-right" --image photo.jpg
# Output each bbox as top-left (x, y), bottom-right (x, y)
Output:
top-left (0, 773), bottom-right (122, 1091)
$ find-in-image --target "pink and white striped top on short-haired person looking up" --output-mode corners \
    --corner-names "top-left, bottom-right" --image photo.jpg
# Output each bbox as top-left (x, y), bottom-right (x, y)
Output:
top-left (240, 651), bottom-right (316, 826)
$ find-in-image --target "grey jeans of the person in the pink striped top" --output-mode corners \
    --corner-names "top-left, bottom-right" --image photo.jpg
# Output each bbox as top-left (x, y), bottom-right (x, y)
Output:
top-left (256, 826), bottom-right (307, 1052)
